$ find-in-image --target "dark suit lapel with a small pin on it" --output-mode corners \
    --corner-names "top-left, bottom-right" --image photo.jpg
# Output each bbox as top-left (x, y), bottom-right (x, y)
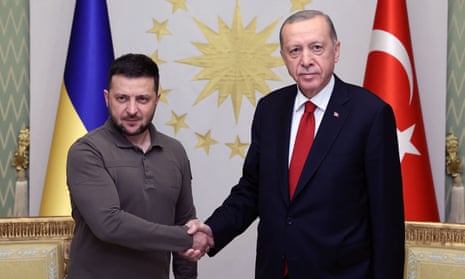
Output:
top-left (294, 77), bottom-right (349, 202)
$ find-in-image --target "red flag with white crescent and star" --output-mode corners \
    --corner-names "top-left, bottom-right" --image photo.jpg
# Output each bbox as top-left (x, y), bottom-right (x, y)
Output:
top-left (364, 0), bottom-right (439, 221)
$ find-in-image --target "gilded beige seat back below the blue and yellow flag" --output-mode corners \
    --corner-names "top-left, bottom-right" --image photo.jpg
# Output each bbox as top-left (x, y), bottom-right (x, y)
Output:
top-left (0, 217), bottom-right (74, 279)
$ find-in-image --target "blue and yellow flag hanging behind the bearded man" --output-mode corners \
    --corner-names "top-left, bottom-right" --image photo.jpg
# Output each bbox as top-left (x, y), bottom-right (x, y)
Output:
top-left (39, 0), bottom-right (114, 216)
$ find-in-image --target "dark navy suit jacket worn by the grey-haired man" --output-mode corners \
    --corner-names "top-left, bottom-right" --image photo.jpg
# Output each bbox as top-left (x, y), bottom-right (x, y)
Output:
top-left (206, 77), bottom-right (404, 279)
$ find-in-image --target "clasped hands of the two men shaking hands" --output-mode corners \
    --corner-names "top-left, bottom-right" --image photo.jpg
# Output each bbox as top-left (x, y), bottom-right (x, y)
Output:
top-left (179, 219), bottom-right (215, 261)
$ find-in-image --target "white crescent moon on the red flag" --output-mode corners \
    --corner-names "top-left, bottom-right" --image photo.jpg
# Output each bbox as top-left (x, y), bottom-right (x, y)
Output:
top-left (368, 29), bottom-right (413, 104)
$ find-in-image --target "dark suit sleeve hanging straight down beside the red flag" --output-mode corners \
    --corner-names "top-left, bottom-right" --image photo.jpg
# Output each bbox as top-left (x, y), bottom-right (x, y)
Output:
top-left (365, 105), bottom-right (405, 278)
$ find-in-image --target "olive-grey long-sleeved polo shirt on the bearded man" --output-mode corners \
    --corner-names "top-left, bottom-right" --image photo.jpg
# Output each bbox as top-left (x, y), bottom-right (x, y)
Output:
top-left (67, 120), bottom-right (197, 279)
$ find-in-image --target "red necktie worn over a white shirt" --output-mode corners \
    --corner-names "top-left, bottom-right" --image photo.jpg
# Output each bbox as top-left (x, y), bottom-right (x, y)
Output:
top-left (289, 101), bottom-right (316, 199)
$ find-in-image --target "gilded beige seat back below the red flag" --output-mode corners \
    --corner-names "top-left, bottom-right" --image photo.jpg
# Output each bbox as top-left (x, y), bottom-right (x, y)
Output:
top-left (404, 222), bottom-right (465, 279)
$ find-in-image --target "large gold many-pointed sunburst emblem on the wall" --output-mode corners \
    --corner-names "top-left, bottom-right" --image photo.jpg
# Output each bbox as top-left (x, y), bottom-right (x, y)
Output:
top-left (177, 2), bottom-right (283, 122)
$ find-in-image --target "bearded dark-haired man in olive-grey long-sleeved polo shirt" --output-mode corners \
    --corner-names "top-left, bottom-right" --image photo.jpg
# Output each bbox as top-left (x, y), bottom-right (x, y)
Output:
top-left (67, 54), bottom-right (212, 279)
